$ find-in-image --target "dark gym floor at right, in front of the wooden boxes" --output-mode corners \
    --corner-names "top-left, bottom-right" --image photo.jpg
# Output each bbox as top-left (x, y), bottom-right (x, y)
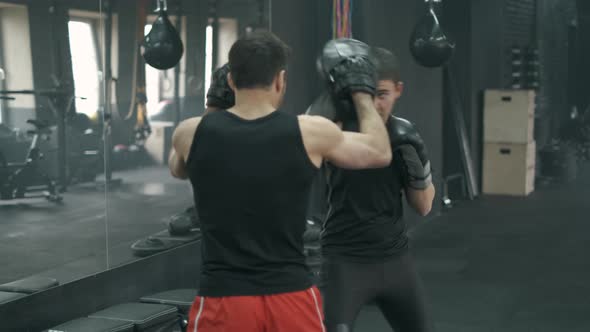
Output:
top-left (355, 166), bottom-right (590, 332)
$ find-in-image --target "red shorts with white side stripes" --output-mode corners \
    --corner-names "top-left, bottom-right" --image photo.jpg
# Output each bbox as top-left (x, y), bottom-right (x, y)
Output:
top-left (186, 287), bottom-right (326, 332)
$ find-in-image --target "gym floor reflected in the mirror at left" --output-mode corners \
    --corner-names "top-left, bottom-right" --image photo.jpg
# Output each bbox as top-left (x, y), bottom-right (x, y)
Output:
top-left (0, 167), bottom-right (192, 283)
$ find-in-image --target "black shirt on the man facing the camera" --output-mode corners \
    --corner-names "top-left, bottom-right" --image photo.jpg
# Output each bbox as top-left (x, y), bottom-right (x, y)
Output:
top-left (322, 121), bottom-right (408, 261)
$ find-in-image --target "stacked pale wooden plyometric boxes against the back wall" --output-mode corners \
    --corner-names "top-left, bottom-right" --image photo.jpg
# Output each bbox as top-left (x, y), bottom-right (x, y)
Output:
top-left (483, 90), bottom-right (536, 196)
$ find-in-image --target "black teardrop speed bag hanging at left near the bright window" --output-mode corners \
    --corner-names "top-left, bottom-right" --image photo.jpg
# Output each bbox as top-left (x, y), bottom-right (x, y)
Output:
top-left (141, 0), bottom-right (184, 70)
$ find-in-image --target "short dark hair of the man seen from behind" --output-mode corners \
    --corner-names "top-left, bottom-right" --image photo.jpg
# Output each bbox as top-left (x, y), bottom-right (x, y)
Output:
top-left (229, 31), bottom-right (291, 89)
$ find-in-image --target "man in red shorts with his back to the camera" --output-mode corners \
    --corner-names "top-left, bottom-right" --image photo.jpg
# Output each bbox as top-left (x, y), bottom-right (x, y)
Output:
top-left (169, 32), bottom-right (391, 332)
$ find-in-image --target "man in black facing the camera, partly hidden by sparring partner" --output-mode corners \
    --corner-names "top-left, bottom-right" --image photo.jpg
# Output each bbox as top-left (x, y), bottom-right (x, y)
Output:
top-left (321, 49), bottom-right (434, 332)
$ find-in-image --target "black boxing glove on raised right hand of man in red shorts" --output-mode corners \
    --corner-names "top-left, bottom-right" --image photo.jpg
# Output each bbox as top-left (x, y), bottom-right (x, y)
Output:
top-left (329, 55), bottom-right (377, 99)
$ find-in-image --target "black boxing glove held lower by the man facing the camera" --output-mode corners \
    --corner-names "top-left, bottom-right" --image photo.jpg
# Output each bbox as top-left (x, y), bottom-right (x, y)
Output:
top-left (388, 116), bottom-right (432, 190)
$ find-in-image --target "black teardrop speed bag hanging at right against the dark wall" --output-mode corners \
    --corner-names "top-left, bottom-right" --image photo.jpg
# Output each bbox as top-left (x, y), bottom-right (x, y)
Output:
top-left (410, 0), bottom-right (455, 68)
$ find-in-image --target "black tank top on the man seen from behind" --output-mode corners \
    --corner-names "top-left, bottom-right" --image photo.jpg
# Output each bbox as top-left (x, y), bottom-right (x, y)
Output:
top-left (187, 111), bottom-right (317, 296)
